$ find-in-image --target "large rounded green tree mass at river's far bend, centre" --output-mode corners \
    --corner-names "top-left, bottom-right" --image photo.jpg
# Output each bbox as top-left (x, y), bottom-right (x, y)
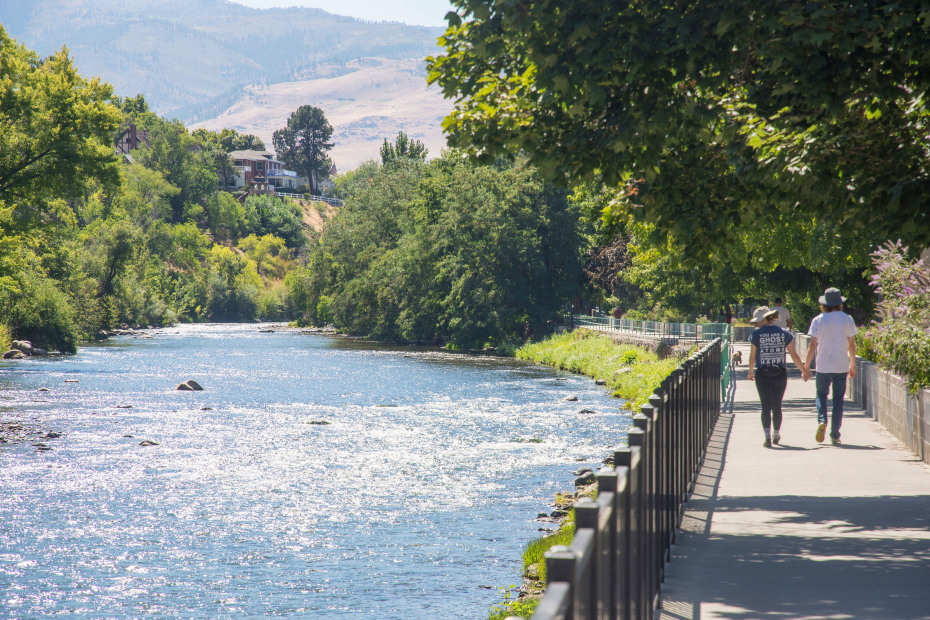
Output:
top-left (316, 152), bottom-right (584, 348)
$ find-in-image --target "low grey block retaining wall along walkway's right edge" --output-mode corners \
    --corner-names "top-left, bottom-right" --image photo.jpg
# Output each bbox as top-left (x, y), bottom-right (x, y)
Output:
top-left (795, 333), bottom-right (930, 464)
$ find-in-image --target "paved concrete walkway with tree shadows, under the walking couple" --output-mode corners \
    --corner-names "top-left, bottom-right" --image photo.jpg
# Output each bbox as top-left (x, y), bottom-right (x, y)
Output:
top-left (656, 345), bottom-right (930, 620)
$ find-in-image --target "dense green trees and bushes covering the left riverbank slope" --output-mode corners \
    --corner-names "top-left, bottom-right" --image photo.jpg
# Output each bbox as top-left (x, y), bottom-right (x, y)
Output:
top-left (0, 27), bottom-right (316, 352)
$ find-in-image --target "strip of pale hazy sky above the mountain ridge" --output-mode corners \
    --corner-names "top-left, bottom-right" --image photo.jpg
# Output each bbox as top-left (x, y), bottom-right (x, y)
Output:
top-left (232, 0), bottom-right (452, 27)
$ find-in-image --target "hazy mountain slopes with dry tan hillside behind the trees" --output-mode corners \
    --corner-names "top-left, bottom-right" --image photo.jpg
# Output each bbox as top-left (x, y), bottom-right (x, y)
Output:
top-left (0, 0), bottom-right (448, 157)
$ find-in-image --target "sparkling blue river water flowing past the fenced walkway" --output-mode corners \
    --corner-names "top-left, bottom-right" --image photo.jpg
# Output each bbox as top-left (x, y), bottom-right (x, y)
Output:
top-left (0, 325), bottom-right (630, 619)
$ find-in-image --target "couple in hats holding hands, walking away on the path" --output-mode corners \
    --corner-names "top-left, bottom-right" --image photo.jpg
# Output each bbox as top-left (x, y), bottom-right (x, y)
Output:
top-left (748, 287), bottom-right (856, 448)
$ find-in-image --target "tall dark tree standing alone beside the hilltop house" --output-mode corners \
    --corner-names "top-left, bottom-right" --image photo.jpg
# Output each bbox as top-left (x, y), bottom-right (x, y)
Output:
top-left (272, 105), bottom-right (333, 194)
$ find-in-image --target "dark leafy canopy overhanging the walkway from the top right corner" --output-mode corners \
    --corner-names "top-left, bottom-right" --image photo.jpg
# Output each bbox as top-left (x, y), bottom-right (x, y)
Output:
top-left (428, 0), bottom-right (930, 260)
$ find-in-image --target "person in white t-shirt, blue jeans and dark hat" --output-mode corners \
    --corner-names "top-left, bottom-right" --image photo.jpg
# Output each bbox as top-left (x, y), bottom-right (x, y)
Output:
top-left (805, 287), bottom-right (856, 445)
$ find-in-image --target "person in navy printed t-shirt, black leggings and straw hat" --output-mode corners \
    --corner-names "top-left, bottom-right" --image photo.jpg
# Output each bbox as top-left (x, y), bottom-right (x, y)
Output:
top-left (748, 306), bottom-right (810, 448)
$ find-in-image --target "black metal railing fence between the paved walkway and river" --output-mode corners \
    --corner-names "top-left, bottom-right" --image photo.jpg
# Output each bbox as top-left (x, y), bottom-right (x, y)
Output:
top-left (520, 339), bottom-right (722, 620)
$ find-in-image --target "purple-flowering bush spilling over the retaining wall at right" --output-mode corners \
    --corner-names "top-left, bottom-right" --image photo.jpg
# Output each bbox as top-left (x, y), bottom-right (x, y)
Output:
top-left (861, 241), bottom-right (930, 391)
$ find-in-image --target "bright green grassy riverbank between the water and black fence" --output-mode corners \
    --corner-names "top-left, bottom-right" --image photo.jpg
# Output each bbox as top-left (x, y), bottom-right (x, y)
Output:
top-left (488, 328), bottom-right (687, 620)
